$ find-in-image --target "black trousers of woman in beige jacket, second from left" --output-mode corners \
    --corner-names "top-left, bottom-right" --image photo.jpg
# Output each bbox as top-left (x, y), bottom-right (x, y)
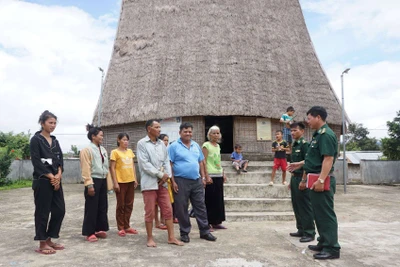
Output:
top-left (82, 178), bottom-right (109, 236)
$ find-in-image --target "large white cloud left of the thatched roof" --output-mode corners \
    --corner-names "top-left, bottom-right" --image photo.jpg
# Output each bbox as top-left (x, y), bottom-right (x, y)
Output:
top-left (0, 0), bottom-right (117, 151)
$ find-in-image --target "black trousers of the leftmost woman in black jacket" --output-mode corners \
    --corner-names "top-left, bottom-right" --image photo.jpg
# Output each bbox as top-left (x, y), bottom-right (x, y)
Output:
top-left (32, 178), bottom-right (65, 241)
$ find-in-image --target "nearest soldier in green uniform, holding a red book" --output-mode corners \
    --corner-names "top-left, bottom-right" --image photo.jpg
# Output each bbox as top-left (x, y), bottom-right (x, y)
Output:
top-left (303, 106), bottom-right (340, 260)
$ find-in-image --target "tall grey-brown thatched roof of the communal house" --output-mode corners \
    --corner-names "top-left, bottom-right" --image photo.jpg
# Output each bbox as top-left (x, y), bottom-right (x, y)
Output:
top-left (94, 0), bottom-right (341, 126)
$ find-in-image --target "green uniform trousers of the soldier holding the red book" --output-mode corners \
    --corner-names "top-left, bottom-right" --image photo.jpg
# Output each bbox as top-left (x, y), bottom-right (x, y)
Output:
top-left (310, 176), bottom-right (340, 252)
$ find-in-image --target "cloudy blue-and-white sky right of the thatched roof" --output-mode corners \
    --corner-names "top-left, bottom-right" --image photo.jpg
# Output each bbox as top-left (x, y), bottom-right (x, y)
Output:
top-left (301, 0), bottom-right (400, 138)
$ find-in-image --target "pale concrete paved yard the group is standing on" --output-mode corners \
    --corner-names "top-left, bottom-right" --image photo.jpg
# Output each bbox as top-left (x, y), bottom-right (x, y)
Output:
top-left (0, 185), bottom-right (400, 267)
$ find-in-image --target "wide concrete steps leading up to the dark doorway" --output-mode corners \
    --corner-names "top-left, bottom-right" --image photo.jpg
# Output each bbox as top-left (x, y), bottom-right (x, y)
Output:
top-left (222, 161), bottom-right (294, 221)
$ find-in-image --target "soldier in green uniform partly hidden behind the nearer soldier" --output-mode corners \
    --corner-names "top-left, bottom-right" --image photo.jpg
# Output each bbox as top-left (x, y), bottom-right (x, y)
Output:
top-left (289, 122), bottom-right (315, 242)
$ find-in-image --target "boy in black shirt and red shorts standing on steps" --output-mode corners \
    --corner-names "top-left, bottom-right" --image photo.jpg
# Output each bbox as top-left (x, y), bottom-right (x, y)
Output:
top-left (269, 130), bottom-right (290, 185)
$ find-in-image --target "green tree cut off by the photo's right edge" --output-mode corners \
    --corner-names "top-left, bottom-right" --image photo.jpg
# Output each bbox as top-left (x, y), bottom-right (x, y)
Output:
top-left (382, 110), bottom-right (400, 160)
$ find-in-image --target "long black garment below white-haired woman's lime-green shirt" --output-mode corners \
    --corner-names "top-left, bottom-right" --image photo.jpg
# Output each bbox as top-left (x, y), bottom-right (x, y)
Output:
top-left (205, 176), bottom-right (225, 225)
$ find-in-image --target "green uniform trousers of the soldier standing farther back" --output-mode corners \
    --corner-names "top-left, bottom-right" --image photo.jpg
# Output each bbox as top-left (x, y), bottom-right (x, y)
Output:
top-left (290, 176), bottom-right (315, 237)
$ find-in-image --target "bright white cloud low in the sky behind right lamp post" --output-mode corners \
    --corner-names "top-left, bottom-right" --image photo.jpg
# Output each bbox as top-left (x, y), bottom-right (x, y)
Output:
top-left (326, 61), bottom-right (400, 138)
